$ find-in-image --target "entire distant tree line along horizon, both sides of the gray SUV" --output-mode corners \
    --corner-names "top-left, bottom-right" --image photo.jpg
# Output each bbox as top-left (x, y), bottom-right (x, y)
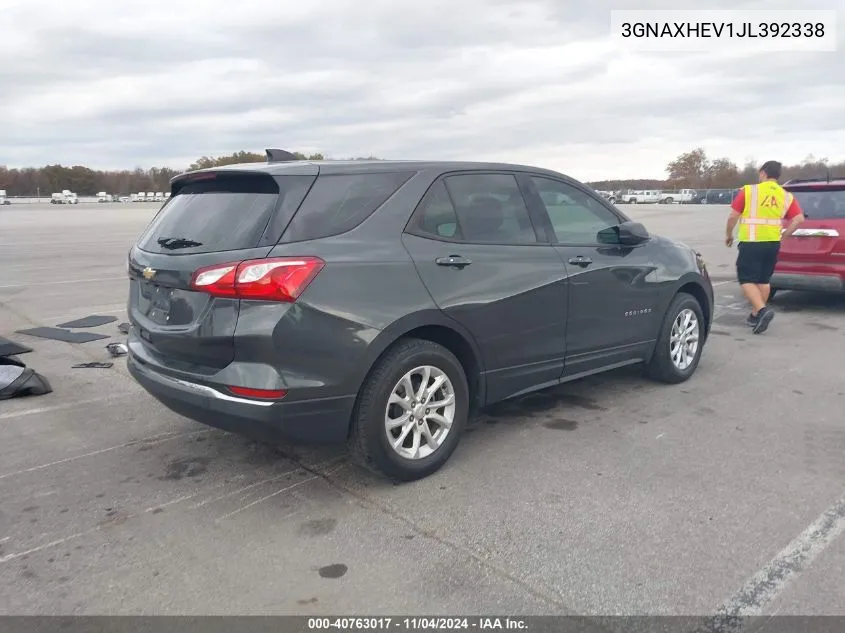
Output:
top-left (0, 147), bottom-right (845, 196)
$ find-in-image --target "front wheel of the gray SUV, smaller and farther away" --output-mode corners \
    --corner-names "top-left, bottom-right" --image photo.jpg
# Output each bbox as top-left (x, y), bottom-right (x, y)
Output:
top-left (646, 292), bottom-right (706, 384)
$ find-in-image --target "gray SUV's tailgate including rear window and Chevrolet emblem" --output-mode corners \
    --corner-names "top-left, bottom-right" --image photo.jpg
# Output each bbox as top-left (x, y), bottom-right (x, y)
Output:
top-left (128, 171), bottom-right (314, 373)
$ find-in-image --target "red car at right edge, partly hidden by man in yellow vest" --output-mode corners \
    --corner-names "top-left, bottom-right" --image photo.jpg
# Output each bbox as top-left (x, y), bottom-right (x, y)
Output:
top-left (771, 178), bottom-right (845, 296)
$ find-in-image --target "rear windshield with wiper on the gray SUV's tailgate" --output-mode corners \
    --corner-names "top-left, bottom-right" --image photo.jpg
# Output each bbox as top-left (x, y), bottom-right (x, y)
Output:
top-left (138, 173), bottom-right (314, 254)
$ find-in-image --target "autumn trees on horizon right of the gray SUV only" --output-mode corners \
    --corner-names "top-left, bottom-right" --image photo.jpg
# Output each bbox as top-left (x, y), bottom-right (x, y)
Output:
top-left (589, 147), bottom-right (845, 191)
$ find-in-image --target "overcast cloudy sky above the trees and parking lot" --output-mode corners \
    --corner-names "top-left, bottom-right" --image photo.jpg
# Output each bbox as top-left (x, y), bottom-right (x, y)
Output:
top-left (0, 0), bottom-right (845, 180)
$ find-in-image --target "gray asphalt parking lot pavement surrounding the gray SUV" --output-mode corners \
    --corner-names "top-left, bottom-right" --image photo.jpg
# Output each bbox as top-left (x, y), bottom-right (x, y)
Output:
top-left (0, 204), bottom-right (845, 615)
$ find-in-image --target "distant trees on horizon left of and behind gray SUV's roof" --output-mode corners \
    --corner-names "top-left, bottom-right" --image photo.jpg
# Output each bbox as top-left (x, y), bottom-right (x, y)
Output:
top-left (0, 151), bottom-right (375, 197)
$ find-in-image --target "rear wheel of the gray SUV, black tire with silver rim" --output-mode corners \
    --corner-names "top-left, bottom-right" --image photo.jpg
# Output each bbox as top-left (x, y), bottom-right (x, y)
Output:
top-left (349, 339), bottom-right (469, 481)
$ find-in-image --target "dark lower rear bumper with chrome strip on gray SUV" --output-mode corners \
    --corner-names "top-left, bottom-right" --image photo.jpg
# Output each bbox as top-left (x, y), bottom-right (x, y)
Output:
top-left (127, 352), bottom-right (355, 444)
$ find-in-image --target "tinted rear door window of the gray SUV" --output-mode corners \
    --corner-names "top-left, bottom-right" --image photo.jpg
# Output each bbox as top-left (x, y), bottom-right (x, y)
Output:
top-left (444, 174), bottom-right (537, 244)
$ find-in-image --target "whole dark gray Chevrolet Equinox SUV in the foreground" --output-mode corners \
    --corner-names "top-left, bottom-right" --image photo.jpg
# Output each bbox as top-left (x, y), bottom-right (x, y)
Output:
top-left (128, 150), bottom-right (713, 481)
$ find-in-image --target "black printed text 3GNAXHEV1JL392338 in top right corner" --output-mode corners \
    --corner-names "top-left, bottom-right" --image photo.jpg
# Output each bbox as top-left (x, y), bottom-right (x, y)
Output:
top-left (622, 22), bottom-right (825, 39)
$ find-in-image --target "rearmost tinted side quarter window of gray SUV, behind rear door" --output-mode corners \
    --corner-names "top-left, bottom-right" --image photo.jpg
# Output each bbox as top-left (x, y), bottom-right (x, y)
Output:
top-left (282, 172), bottom-right (413, 242)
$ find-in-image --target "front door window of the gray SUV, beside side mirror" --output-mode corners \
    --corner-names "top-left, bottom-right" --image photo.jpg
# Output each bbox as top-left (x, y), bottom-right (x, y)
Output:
top-left (531, 176), bottom-right (619, 244)
